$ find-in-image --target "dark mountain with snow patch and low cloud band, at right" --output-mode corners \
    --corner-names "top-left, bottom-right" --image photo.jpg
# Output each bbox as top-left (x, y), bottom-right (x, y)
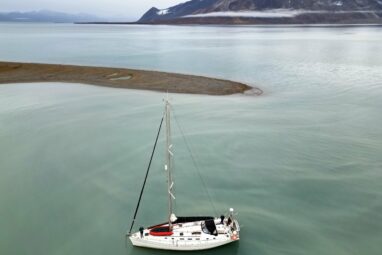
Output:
top-left (138, 0), bottom-right (382, 24)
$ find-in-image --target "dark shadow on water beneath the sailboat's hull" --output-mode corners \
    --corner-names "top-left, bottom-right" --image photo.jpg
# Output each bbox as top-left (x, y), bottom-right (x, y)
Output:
top-left (126, 242), bottom-right (240, 255)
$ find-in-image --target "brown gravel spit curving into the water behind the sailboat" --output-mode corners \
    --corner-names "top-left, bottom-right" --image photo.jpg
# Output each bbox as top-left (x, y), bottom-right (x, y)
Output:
top-left (0, 61), bottom-right (262, 95)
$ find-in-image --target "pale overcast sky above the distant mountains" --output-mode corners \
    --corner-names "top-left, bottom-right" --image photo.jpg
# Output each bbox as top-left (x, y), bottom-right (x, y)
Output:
top-left (0, 0), bottom-right (186, 19)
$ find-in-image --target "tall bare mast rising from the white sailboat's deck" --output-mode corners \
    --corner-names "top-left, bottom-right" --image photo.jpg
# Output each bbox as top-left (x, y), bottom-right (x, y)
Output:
top-left (165, 99), bottom-right (175, 230)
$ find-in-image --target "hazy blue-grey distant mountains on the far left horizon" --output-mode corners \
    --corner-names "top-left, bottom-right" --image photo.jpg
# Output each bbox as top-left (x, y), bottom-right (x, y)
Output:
top-left (0, 10), bottom-right (101, 23)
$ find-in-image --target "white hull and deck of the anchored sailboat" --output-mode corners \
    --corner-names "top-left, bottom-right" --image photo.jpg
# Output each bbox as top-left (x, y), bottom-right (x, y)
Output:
top-left (129, 219), bottom-right (240, 251)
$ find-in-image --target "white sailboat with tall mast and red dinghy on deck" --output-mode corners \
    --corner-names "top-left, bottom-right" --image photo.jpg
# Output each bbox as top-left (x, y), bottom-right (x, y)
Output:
top-left (126, 99), bottom-right (240, 251)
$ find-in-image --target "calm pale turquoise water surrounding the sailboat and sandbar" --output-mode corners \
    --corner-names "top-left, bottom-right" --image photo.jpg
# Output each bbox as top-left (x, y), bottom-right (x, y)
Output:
top-left (0, 24), bottom-right (382, 255)
